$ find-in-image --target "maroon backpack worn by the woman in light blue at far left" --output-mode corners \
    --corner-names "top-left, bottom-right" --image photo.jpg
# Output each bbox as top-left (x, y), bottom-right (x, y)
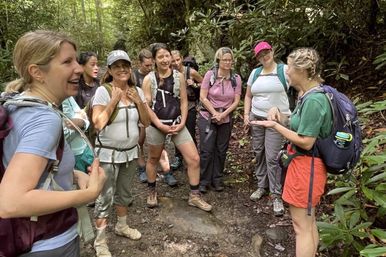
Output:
top-left (0, 95), bottom-right (78, 257)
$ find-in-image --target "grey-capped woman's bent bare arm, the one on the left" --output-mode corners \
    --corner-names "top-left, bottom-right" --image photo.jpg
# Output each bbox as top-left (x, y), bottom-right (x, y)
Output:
top-left (92, 87), bottom-right (122, 131)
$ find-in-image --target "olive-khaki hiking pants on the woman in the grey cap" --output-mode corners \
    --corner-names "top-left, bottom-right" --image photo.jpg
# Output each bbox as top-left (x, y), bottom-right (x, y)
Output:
top-left (94, 160), bottom-right (138, 218)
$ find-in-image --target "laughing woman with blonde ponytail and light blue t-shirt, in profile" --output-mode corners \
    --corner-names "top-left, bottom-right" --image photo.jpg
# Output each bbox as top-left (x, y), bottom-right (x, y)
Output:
top-left (0, 30), bottom-right (105, 257)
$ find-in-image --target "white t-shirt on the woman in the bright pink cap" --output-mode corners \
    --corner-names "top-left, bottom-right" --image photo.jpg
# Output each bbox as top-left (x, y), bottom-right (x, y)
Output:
top-left (247, 65), bottom-right (291, 118)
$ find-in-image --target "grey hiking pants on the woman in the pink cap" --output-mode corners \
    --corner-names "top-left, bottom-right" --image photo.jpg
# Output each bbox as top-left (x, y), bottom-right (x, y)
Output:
top-left (249, 113), bottom-right (284, 195)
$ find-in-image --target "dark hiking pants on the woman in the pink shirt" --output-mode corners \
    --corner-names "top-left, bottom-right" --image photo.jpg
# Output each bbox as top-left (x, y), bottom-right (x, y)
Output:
top-left (198, 115), bottom-right (232, 186)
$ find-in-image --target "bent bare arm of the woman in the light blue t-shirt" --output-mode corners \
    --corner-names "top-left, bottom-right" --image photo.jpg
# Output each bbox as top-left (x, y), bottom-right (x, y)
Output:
top-left (0, 153), bottom-right (106, 218)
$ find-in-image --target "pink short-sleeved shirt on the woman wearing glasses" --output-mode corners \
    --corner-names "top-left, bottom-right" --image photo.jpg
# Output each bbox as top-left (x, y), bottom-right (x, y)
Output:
top-left (200, 70), bottom-right (241, 122)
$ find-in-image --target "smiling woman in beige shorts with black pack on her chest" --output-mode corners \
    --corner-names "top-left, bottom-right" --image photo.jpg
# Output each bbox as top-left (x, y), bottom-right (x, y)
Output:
top-left (143, 43), bottom-right (212, 211)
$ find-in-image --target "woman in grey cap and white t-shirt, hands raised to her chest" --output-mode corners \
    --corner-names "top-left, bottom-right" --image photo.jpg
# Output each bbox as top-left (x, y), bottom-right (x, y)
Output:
top-left (92, 50), bottom-right (150, 257)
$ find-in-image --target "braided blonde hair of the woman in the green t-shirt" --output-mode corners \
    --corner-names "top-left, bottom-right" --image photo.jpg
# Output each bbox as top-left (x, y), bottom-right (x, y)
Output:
top-left (287, 47), bottom-right (324, 82)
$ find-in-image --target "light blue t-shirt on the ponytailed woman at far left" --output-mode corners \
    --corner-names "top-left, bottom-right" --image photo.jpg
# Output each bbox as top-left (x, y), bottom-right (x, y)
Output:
top-left (3, 97), bottom-right (77, 252)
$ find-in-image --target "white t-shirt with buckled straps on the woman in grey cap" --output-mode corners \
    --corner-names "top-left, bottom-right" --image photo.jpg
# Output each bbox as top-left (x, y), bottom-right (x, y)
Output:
top-left (93, 87), bottom-right (145, 163)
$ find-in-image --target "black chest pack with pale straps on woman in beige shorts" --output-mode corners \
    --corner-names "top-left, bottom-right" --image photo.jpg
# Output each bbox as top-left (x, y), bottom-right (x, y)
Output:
top-left (149, 70), bottom-right (181, 125)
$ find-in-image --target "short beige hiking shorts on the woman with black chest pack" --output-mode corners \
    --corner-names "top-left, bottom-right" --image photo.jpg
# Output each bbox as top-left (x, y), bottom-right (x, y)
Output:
top-left (146, 125), bottom-right (193, 145)
